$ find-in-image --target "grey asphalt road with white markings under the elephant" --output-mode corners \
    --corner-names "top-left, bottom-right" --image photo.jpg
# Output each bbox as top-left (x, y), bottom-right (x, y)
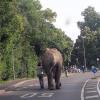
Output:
top-left (0, 72), bottom-right (100, 100)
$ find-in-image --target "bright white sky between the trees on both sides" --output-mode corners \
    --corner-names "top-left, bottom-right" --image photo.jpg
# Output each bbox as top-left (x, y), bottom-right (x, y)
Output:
top-left (39, 0), bottom-right (100, 42)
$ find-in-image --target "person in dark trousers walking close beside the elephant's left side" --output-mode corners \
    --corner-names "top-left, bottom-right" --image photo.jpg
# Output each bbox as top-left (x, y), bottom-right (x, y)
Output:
top-left (37, 62), bottom-right (44, 89)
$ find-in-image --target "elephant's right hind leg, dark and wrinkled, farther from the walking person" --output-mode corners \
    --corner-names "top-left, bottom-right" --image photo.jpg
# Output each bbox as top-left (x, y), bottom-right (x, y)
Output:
top-left (55, 66), bottom-right (61, 89)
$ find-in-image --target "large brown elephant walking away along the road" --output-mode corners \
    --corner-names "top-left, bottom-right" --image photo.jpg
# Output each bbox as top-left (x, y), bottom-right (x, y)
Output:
top-left (41, 48), bottom-right (63, 90)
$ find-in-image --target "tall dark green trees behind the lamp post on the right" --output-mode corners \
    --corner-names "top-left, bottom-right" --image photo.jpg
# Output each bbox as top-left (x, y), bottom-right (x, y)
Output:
top-left (72, 7), bottom-right (100, 68)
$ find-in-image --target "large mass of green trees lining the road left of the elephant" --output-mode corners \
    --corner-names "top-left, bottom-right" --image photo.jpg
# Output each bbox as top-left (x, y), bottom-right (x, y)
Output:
top-left (0, 0), bottom-right (73, 80)
